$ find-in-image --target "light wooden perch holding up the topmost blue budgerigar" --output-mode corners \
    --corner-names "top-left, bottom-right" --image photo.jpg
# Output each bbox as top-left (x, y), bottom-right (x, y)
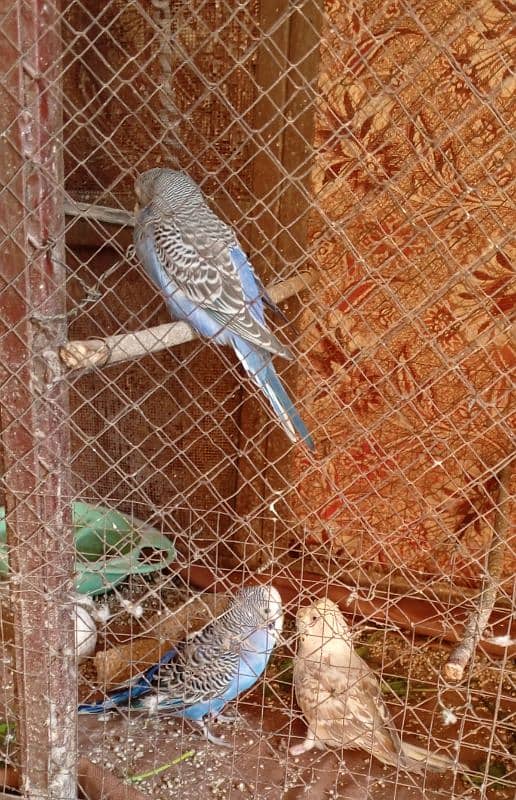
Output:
top-left (59, 272), bottom-right (316, 370)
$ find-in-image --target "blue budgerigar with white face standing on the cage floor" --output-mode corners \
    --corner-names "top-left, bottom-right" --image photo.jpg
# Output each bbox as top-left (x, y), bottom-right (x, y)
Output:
top-left (79, 585), bottom-right (283, 743)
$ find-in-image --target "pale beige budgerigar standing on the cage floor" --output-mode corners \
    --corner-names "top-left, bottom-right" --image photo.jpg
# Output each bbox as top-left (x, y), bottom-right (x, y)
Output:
top-left (290, 599), bottom-right (454, 772)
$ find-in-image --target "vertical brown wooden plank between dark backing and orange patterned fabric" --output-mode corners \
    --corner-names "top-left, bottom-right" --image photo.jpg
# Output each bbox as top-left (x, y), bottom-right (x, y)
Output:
top-left (236, 0), bottom-right (322, 568)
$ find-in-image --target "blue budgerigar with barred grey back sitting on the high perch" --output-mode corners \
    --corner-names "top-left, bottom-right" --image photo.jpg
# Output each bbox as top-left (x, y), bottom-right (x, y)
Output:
top-left (134, 168), bottom-right (314, 450)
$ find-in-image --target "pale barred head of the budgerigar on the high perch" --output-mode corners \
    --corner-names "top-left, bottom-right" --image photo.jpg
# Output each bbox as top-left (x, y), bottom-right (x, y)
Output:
top-left (134, 167), bottom-right (205, 215)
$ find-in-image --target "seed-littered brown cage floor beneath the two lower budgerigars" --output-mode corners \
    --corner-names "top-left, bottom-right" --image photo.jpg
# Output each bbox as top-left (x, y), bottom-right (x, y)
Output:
top-left (74, 689), bottom-right (512, 800)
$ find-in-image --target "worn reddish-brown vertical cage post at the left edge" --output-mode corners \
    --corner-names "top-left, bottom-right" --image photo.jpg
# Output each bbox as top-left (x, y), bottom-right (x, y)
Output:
top-left (0, 0), bottom-right (77, 800)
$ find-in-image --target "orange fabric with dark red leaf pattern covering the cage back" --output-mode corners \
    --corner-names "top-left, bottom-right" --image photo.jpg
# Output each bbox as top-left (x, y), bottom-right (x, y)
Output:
top-left (296, 0), bottom-right (516, 583)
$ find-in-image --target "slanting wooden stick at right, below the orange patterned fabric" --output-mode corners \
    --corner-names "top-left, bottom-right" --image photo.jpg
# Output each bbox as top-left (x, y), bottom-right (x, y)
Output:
top-left (443, 462), bottom-right (512, 683)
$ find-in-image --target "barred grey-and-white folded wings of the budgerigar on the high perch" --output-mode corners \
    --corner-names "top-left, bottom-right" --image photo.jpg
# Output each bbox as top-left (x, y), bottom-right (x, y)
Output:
top-left (135, 208), bottom-right (292, 358)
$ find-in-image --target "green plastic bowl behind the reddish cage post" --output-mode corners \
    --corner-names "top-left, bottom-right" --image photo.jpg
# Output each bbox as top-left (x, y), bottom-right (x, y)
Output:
top-left (0, 501), bottom-right (176, 594)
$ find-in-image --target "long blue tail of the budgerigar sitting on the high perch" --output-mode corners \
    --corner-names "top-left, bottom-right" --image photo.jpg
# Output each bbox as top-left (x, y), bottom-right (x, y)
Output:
top-left (233, 337), bottom-right (315, 450)
